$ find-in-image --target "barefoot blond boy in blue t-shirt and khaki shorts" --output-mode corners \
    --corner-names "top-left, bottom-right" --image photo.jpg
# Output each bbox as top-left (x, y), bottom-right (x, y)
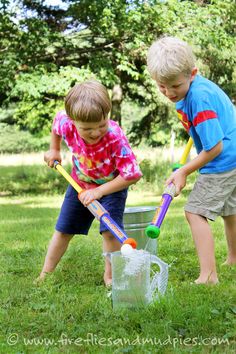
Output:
top-left (147, 36), bottom-right (236, 284)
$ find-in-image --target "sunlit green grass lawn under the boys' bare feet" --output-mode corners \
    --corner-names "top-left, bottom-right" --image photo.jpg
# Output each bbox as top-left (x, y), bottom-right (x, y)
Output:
top-left (0, 191), bottom-right (236, 354)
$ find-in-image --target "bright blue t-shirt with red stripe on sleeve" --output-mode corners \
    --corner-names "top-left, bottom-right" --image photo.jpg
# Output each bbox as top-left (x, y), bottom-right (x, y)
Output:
top-left (176, 75), bottom-right (236, 173)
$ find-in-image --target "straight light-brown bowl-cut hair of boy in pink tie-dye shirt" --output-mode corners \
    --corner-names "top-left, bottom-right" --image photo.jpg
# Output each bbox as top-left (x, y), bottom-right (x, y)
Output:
top-left (65, 80), bottom-right (111, 122)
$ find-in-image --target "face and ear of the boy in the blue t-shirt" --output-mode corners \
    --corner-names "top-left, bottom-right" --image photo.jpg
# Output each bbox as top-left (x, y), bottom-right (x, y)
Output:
top-left (157, 69), bottom-right (197, 102)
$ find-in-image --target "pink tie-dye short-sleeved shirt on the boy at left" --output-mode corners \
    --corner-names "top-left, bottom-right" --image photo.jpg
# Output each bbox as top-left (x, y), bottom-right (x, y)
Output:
top-left (53, 111), bottom-right (142, 189)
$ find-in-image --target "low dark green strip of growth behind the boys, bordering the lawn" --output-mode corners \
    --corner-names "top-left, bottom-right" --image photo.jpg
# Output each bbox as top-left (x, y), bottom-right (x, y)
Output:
top-left (0, 159), bottom-right (195, 196)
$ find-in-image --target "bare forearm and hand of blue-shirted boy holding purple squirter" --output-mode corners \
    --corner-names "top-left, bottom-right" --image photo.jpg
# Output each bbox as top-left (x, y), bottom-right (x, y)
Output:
top-left (166, 141), bottom-right (223, 195)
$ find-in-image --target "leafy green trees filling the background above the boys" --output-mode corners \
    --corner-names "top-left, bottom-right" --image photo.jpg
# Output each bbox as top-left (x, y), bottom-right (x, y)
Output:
top-left (0, 0), bottom-right (236, 151)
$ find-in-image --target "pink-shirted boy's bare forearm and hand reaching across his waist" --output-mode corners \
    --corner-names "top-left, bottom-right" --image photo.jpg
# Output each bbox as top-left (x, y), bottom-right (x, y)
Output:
top-left (79, 175), bottom-right (141, 206)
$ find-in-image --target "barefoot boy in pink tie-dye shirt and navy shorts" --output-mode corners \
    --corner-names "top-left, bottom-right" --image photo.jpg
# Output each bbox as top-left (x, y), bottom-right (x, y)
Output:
top-left (39, 80), bottom-right (142, 285)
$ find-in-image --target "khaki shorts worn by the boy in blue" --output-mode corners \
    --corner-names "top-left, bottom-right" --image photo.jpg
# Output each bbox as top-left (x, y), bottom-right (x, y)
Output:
top-left (184, 169), bottom-right (236, 221)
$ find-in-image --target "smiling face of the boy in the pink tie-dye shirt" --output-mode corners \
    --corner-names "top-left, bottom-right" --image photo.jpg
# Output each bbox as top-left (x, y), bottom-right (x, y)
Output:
top-left (73, 118), bottom-right (108, 145)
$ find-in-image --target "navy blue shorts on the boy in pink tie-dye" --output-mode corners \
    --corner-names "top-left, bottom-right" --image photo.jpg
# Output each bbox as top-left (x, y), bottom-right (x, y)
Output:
top-left (55, 185), bottom-right (128, 235)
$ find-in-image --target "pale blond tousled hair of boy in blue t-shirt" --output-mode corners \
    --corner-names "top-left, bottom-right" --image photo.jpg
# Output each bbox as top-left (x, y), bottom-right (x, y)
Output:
top-left (147, 36), bottom-right (195, 82)
